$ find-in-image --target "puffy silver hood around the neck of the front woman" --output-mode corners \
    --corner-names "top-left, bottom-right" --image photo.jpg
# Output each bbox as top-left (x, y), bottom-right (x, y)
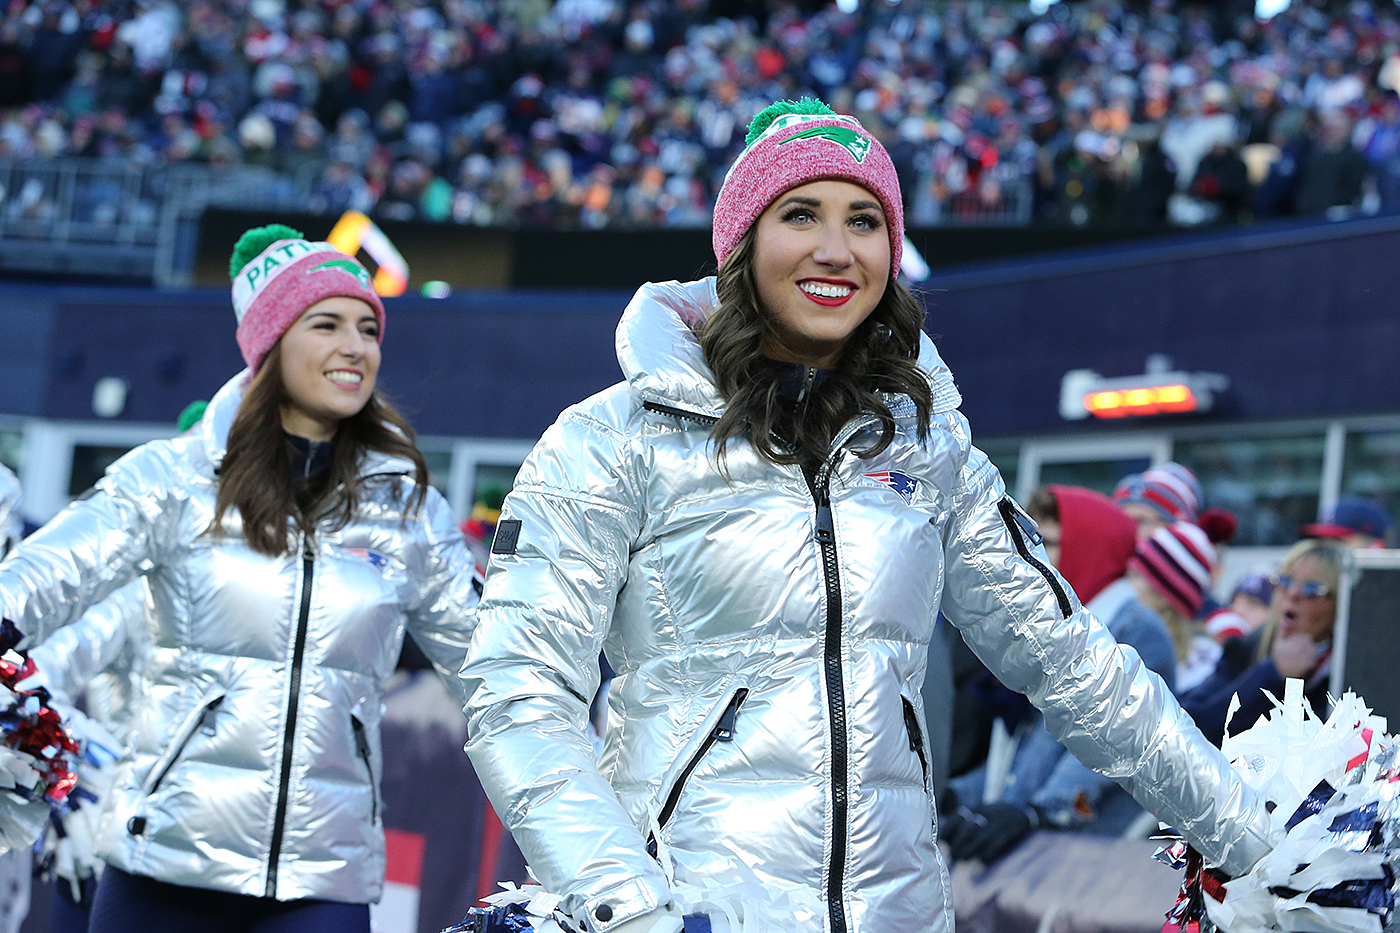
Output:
top-left (617, 276), bottom-right (962, 417)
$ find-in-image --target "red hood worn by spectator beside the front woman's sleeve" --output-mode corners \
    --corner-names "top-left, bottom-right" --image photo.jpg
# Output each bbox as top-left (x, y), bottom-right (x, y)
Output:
top-left (1049, 485), bottom-right (1137, 602)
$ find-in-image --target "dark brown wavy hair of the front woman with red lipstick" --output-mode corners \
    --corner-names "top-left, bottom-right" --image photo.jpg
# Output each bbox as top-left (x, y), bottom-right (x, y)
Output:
top-left (699, 224), bottom-right (934, 467)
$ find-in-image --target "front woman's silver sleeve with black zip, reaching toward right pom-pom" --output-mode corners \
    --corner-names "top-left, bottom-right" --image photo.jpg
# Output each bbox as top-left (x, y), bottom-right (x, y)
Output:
top-left (942, 450), bottom-right (1271, 874)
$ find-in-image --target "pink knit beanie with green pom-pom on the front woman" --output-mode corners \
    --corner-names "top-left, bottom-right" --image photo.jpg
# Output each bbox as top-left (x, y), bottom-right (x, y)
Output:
top-left (711, 97), bottom-right (904, 276)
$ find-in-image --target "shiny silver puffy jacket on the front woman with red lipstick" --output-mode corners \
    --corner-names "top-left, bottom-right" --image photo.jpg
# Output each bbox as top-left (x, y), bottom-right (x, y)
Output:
top-left (462, 279), bottom-right (1268, 933)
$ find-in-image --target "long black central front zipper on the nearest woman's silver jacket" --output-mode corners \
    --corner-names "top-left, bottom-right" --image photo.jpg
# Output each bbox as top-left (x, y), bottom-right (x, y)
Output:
top-left (811, 471), bottom-right (850, 933)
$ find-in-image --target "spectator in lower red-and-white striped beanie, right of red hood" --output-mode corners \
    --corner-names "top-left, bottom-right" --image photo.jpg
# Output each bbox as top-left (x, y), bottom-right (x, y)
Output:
top-left (1128, 521), bottom-right (1221, 693)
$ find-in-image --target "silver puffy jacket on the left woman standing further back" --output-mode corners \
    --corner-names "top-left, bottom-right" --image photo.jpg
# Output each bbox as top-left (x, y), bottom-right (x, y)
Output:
top-left (0, 377), bottom-right (476, 904)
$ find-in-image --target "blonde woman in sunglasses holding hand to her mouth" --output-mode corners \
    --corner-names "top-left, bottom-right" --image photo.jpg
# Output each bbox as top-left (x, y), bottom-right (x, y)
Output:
top-left (1180, 538), bottom-right (1345, 745)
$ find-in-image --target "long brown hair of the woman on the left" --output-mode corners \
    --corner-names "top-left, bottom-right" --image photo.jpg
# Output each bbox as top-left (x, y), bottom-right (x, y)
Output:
top-left (209, 340), bottom-right (428, 556)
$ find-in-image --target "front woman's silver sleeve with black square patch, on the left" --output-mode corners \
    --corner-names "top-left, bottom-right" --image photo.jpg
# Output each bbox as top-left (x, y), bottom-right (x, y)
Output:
top-left (462, 409), bottom-right (671, 932)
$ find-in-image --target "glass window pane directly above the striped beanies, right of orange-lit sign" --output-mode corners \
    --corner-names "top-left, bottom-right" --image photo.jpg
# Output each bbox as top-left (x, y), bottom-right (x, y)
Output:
top-left (1175, 433), bottom-right (1326, 546)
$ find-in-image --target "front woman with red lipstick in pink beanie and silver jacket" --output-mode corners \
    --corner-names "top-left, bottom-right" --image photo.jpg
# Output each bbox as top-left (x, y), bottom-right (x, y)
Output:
top-left (462, 99), bottom-right (1268, 933)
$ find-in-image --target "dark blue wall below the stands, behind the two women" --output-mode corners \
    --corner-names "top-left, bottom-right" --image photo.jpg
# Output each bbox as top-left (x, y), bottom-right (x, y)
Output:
top-left (0, 219), bottom-right (1400, 438)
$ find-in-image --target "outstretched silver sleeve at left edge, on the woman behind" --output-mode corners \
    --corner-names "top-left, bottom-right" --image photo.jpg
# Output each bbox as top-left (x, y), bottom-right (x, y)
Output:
top-left (0, 441), bottom-right (183, 644)
